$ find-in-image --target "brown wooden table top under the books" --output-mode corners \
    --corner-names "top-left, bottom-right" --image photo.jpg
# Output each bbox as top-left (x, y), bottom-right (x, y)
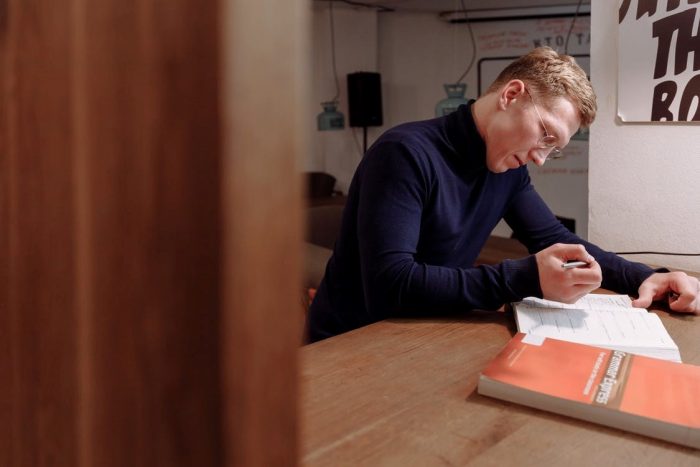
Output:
top-left (301, 247), bottom-right (700, 467)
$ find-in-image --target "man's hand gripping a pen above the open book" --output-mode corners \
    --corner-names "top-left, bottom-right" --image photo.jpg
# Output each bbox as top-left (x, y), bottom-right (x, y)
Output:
top-left (535, 243), bottom-right (603, 303)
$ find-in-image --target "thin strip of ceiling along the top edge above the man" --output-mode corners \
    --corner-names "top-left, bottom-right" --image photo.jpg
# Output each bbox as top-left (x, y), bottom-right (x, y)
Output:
top-left (326, 0), bottom-right (591, 13)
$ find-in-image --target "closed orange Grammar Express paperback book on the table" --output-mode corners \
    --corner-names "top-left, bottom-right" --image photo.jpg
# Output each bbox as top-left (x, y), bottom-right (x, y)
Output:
top-left (478, 333), bottom-right (700, 449)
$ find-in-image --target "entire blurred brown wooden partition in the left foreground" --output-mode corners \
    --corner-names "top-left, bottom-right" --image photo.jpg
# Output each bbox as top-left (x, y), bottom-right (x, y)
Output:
top-left (0, 0), bottom-right (308, 466)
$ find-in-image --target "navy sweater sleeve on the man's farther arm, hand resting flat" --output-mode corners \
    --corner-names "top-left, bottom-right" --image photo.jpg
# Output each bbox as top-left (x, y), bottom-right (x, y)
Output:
top-left (505, 176), bottom-right (654, 295)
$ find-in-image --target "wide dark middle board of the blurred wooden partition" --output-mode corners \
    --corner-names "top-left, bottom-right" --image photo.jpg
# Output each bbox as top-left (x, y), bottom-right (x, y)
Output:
top-left (75, 0), bottom-right (223, 466)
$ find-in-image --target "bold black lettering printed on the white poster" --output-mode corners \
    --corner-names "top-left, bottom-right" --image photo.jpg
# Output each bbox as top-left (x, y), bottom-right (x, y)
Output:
top-left (618, 0), bottom-right (700, 121)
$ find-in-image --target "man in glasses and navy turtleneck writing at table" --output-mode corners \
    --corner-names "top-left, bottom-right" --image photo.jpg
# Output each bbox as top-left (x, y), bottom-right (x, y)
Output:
top-left (308, 47), bottom-right (700, 342)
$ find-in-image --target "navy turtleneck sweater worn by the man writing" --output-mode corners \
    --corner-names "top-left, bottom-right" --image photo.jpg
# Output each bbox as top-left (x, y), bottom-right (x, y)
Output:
top-left (308, 101), bottom-right (653, 342)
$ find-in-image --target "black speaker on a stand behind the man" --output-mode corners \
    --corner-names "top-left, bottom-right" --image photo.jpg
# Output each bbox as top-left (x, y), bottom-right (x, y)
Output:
top-left (348, 71), bottom-right (382, 127)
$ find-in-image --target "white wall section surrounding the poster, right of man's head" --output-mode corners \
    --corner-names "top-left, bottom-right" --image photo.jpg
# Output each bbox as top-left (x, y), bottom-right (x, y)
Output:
top-left (588, 0), bottom-right (700, 271)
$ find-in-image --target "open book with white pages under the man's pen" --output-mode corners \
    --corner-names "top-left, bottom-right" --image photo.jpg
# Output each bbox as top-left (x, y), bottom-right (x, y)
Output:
top-left (513, 294), bottom-right (681, 362)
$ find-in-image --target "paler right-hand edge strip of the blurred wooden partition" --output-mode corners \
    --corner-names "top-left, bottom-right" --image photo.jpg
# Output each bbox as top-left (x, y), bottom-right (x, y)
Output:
top-left (223, 0), bottom-right (308, 465)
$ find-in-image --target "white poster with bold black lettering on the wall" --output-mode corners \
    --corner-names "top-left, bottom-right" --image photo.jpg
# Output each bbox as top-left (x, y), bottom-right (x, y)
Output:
top-left (617, 0), bottom-right (700, 122)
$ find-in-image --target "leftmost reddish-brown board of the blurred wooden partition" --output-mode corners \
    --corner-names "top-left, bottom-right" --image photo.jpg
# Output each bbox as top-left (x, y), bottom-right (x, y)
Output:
top-left (0, 0), bottom-right (78, 466)
